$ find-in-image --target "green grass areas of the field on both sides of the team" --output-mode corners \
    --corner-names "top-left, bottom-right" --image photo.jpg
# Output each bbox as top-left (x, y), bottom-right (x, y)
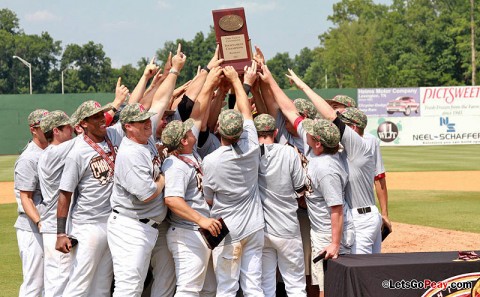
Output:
top-left (0, 145), bottom-right (480, 296)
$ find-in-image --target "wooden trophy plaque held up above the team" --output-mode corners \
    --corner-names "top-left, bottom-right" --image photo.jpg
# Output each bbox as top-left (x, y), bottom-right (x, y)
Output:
top-left (212, 7), bottom-right (252, 74)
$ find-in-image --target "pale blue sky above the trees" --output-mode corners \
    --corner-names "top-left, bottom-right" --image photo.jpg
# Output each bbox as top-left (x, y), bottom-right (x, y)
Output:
top-left (0, 0), bottom-right (392, 68)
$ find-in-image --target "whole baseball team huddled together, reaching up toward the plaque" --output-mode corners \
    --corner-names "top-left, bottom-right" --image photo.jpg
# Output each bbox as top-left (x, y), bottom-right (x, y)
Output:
top-left (14, 44), bottom-right (392, 297)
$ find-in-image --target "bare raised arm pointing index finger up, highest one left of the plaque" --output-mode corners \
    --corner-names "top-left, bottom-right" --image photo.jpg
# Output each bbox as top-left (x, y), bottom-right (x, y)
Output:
top-left (150, 44), bottom-right (187, 118)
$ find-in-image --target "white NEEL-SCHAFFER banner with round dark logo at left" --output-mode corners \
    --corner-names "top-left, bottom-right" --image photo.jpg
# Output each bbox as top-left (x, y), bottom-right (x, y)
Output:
top-left (365, 116), bottom-right (480, 146)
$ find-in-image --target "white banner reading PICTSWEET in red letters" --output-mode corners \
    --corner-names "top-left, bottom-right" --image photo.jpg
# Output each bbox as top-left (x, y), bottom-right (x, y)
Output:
top-left (420, 86), bottom-right (480, 117)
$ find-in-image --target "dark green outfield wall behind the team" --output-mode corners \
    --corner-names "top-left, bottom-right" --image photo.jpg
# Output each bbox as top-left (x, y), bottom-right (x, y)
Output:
top-left (0, 89), bottom-right (357, 155)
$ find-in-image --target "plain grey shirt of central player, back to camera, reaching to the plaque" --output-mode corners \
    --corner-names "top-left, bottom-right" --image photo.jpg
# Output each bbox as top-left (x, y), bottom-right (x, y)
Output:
top-left (203, 120), bottom-right (265, 245)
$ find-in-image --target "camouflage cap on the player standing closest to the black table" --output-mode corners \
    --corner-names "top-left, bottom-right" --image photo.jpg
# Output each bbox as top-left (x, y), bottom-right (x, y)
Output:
top-left (302, 119), bottom-right (340, 148)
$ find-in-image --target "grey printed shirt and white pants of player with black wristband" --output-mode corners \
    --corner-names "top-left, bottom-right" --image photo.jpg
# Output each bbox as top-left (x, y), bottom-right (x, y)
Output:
top-left (60, 123), bottom-right (124, 296)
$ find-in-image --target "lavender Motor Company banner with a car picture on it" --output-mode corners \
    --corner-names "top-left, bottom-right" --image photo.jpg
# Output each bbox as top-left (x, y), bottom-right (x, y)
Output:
top-left (357, 88), bottom-right (421, 117)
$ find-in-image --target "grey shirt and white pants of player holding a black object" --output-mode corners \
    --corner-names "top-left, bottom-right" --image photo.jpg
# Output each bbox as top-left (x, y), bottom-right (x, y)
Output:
top-left (162, 130), bottom-right (216, 296)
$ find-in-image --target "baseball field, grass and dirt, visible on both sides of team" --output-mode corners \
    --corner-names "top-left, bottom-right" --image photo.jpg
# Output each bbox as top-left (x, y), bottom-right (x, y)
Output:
top-left (0, 145), bottom-right (480, 296)
